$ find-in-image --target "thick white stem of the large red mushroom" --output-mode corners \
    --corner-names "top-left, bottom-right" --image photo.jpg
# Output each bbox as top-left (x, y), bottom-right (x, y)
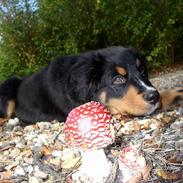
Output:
top-left (80, 149), bottom-right (111, 183)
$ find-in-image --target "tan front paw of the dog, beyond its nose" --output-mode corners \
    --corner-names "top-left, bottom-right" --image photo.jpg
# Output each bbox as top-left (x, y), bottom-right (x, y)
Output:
top-left (160, 88), bottom-right (183, 109)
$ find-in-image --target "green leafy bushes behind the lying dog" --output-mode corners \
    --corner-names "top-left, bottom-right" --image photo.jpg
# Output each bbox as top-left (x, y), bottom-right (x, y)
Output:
top-left (0, 0), bottom-right (183, 80)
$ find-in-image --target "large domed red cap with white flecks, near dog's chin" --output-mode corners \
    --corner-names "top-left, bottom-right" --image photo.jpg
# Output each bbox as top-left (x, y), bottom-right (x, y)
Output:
top-left (64, 101), bottom-right (114, 150)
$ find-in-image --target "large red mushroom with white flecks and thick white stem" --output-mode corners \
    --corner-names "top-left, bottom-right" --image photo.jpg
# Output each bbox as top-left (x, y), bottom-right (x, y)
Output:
top-left (64, 101), bottom-right (114, 183)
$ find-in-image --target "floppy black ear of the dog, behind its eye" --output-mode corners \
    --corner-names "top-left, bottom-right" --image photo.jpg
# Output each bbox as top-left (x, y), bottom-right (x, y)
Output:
top-left (68, 53), bottom-right (109, 103)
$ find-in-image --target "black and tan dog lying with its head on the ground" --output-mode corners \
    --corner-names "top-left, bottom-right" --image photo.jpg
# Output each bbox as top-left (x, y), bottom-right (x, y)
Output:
top-left (0, 46), bottom-right (182, 123)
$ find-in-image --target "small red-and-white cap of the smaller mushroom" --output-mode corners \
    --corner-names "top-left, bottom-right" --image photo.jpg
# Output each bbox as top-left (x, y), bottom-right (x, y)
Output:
top-left (119, 145), bottom-right (146, 170)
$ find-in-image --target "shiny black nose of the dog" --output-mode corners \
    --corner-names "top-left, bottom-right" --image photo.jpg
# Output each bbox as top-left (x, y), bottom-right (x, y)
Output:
top-left (144, 90), bottom-right (160, 104)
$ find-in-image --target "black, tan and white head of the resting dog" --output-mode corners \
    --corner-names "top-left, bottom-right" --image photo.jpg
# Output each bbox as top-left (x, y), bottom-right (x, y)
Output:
top-left (92, 47), bottom-right (160, 116)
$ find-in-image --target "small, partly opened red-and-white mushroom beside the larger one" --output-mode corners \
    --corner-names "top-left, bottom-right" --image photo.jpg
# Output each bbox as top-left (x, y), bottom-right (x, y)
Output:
top-left (118, 144), bottom-right (151, 183)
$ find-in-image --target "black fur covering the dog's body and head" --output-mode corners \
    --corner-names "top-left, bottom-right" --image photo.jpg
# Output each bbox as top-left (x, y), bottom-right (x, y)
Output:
top-left (0, 47), bottom-right (154, 122)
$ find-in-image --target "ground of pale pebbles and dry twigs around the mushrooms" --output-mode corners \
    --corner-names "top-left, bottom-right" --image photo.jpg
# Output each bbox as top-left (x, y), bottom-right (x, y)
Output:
top-left (0, 68), bottom-right (183, 183)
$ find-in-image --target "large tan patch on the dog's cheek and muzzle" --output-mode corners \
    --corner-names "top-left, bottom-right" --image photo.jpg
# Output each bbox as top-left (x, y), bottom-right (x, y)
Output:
top-left (107, 86), bottom-right (151, 116)
